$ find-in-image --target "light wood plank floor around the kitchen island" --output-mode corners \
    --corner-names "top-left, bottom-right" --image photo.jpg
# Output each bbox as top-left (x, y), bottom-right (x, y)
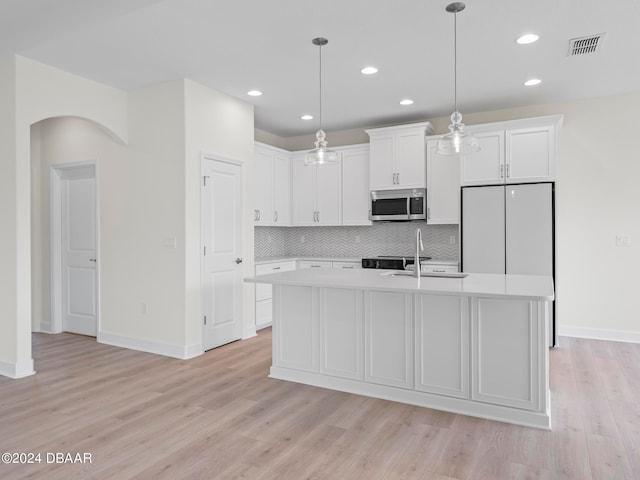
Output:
top-left (0, 330), bottom-right (640, 480)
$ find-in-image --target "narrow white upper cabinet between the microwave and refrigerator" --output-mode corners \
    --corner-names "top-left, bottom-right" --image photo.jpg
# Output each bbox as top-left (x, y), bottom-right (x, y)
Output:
top-left (427, 139), bottom-right (460, 225)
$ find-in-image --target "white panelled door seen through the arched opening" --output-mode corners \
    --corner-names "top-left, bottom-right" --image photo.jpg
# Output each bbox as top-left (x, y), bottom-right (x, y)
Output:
top-left (60, 167), bottom-right (98, 337)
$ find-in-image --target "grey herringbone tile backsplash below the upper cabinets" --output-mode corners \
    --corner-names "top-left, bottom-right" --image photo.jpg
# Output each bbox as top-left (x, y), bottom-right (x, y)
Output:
top-left (254, 222), bottom-right (458, 260)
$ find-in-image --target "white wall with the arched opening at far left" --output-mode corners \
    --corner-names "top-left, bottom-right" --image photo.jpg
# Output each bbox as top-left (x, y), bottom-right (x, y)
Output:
top-left (0, 56), bottom-right (127, 376)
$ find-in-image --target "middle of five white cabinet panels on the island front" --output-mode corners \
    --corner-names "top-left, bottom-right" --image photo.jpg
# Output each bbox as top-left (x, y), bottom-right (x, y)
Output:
top-left (364, 291), bottom-right (414, 388)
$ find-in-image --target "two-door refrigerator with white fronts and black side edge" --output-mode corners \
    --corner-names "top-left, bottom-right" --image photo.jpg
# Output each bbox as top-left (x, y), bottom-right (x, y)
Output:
top-left (461, 183), bottom-right (556, 346)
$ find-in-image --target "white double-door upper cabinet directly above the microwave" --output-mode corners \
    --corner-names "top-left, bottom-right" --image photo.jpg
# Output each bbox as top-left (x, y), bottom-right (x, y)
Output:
top-left (366, 122), bottom-right (433, 190)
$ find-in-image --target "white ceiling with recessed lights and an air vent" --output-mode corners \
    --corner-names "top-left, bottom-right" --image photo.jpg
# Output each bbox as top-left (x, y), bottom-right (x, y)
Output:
top-left (0, 0), bottom-right (640, 137)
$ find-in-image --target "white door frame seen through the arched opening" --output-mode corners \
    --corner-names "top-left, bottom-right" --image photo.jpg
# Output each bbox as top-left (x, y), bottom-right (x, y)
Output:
top-left (49, 160), bottom-right (100, 339)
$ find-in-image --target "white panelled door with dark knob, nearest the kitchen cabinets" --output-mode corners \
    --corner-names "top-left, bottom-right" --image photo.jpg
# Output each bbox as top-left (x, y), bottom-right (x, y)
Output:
top-left (202, 158), bottom-right (243, 350)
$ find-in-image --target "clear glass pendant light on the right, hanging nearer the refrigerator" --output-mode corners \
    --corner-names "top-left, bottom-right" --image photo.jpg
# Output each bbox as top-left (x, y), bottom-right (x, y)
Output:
top-left (436, 2), bottom-right (480, 155)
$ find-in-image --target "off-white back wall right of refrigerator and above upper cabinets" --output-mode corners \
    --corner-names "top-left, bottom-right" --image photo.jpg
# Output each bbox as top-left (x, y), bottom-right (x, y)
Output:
top-left (268, 92), bottom-right (640, 342)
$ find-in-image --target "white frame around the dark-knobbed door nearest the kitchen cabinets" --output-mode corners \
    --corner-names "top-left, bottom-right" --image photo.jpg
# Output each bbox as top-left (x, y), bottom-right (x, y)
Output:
top-left (198, 152), bottom-right (247, 354)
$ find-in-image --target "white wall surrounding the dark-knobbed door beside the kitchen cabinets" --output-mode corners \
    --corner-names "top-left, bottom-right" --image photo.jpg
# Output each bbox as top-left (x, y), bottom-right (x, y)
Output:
top-left (185, 80), bottom-right (255, 343)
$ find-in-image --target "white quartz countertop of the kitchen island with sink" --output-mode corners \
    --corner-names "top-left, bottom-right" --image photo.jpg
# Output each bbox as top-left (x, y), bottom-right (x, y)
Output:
top-left (245, 268), bottom-right (554, 301)
